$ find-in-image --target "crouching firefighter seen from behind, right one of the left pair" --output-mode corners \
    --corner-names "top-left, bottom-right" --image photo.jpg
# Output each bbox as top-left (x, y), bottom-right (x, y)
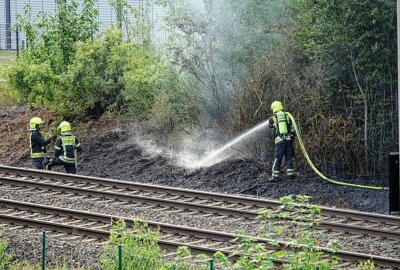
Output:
top-left (46, 121), bottom-right (82, 174)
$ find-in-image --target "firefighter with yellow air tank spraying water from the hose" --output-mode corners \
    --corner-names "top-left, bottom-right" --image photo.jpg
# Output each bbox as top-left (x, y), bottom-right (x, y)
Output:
top-left (268, 101), bottom-right (296, 181)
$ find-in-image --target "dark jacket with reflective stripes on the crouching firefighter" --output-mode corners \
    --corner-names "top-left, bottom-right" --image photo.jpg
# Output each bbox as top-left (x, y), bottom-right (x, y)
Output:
top-left (54, 132), bottom-right (82, 164)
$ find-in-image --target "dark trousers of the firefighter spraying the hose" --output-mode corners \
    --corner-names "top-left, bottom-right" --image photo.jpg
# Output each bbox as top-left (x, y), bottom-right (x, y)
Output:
top-left (272, 141), bottom-right (294, 178)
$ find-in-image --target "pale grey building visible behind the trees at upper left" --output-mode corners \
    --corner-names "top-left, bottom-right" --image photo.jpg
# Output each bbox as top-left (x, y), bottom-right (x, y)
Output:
top-left (0, 0), bottom-right (165, 50)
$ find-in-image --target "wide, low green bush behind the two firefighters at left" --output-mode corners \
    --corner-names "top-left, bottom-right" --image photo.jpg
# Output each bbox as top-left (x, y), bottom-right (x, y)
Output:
top-left (4, 24), bottom-right (199, 125)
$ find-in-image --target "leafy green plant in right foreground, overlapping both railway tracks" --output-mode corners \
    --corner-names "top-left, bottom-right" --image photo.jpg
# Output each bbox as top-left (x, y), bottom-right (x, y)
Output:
top-left (215, 195), bottom-right (340, 269)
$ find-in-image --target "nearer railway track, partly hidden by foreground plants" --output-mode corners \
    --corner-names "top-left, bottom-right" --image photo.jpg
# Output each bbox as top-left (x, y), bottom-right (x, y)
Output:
top-left (0, 199), bottom-right (400, 268)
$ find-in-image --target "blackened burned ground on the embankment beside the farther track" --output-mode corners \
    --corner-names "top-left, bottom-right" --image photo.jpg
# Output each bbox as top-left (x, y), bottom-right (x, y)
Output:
top-left (0, 107), bottom-right (388, 213)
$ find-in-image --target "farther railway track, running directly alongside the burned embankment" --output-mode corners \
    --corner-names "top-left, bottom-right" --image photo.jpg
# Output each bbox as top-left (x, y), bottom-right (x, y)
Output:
top-left (0, 166), bottom-right (400, 243)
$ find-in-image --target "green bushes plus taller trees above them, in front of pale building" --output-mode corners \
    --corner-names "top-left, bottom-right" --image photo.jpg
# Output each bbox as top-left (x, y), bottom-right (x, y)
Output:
top-left (4, 0), bottom-right (199, 131)
